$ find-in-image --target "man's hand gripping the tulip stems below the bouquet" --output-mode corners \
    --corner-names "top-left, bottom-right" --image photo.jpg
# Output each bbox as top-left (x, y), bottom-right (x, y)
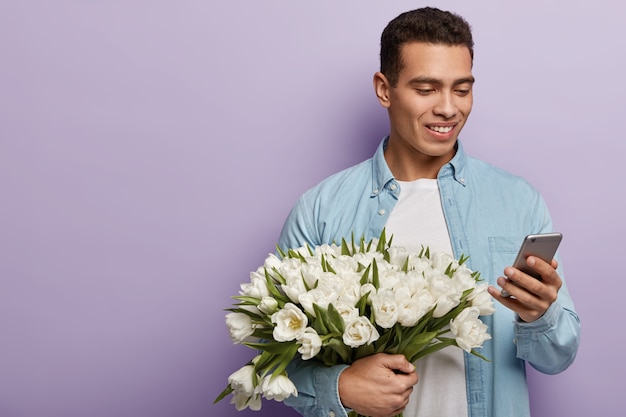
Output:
top-left (339, 353), bottom-right (418, 417)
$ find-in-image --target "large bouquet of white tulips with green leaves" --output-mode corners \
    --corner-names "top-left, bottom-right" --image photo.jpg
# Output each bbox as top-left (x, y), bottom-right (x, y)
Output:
top-left (215, 230), bottom-right (494, 415)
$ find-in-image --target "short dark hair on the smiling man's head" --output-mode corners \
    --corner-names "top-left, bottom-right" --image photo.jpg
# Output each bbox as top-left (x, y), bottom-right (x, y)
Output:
top-left (380, 7), bottom-right (474, 86)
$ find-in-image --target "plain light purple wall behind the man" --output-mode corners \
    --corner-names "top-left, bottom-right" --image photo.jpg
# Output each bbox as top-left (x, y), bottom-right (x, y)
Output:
top-left (0, 0), bottom-right (626, 417)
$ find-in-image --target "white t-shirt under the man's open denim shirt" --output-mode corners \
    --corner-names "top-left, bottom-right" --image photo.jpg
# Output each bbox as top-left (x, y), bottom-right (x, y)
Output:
top-left (385, 179), bottom-right (468, 417)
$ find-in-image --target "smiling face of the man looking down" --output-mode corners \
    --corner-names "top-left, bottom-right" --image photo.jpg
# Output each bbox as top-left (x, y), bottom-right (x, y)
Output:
top-left (375, 42), bottom-right (474, 179)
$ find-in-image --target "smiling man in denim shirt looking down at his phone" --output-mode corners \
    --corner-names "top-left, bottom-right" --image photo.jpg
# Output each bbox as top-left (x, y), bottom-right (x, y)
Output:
top-left (279, 8), bottom-right (580, 417)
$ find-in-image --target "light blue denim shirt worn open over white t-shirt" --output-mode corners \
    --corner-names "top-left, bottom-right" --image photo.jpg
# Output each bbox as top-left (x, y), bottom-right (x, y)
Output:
top-left (278, 139), bottom-right (580, 417)
